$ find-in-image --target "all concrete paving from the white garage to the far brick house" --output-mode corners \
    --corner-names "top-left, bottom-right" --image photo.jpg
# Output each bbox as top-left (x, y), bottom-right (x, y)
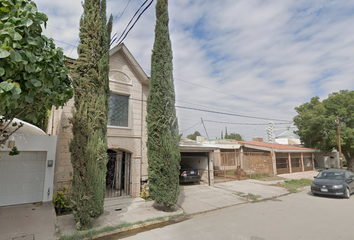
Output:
top-left (0, 171), bottom-right (317, 240)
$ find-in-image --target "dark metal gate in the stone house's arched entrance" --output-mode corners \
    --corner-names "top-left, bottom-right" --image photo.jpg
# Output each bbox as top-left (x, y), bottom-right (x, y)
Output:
top-left (106, 152), bottom-right (130, 198)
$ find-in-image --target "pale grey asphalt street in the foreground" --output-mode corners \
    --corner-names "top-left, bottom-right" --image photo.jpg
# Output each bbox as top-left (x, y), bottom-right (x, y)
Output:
top-left (117, 187), bottom-right (354, 240)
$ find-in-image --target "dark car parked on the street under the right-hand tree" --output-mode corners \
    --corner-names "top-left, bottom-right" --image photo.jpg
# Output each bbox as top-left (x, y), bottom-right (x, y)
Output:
top-left (311, 169), bottom-right (354, 198)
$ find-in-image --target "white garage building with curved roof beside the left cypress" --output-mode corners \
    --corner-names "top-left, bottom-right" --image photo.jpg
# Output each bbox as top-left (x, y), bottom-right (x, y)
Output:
top-left (0, 119), bottom-right (57, 206)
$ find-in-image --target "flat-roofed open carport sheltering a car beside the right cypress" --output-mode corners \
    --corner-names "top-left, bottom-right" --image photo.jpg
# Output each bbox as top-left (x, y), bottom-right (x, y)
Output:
top-left (179, 138), bottom-right (218, 186)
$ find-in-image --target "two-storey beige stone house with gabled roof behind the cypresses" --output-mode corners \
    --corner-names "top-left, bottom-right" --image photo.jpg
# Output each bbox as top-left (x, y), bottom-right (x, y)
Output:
top-left (48, 44), bottom-right (149, 197)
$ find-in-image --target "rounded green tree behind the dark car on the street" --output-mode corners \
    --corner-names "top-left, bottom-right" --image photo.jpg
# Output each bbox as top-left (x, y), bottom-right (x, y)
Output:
top-left (294, 90), bottom-right (354, 171)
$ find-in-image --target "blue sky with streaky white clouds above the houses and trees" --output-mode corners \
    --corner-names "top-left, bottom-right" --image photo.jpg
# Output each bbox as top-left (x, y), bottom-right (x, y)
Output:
top-left (35, 0), bottom-right (354, 140)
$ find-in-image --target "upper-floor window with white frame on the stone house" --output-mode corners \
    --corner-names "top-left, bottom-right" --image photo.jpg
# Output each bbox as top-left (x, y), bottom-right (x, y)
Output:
top-left (108, 93), bottom-right (129, 127)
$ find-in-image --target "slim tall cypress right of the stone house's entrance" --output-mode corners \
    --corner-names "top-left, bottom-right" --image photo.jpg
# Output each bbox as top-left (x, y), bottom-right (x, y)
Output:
top-left (146, 0), bottom-right (181, 210)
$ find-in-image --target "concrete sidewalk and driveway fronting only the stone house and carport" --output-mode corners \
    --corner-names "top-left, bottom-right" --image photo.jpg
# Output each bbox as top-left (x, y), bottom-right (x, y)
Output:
top-left (57, 180), bottom-right (288, 236)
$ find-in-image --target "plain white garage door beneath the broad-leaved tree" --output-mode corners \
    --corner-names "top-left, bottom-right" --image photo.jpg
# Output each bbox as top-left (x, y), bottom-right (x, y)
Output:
top-left (0, 152), bottom-right (46, 206)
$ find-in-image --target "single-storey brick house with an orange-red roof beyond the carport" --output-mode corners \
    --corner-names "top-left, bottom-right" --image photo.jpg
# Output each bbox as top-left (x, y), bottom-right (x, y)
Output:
top-left (199, 138), bottom-right (318, 175)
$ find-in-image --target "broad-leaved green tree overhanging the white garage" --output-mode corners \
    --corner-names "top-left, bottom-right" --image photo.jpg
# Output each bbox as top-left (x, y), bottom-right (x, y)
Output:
top-left (0, 0), bottom-right (72, 145)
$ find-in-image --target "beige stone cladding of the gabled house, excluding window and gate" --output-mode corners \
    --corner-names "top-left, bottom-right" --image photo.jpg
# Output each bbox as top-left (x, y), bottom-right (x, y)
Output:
top-left (54, 47), bottom-right (149, 197)
